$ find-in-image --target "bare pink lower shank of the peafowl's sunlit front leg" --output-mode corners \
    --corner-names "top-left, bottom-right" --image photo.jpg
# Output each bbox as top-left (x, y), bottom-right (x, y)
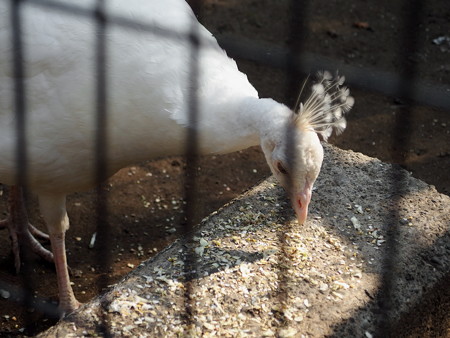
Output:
top-left (50, 232), bottom-right (80, 316)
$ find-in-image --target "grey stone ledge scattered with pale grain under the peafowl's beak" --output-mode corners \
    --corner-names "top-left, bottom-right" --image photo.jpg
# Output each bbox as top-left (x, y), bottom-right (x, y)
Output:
top-left (39, 145), bottom-right (450, 337)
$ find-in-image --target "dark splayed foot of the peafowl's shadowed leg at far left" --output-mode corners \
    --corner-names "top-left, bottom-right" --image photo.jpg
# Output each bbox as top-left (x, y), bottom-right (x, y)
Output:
top-left (0, 217), bottom-right (53, 273)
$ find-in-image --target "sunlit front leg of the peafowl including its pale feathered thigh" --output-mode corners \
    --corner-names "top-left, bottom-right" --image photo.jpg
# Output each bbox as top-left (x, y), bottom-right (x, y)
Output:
top-left (39, 194), bottom-right (80, 315)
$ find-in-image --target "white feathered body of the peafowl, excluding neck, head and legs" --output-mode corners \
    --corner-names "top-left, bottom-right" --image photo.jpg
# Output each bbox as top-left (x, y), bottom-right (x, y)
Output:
top-left (0, 0), bottom-right (287, 192)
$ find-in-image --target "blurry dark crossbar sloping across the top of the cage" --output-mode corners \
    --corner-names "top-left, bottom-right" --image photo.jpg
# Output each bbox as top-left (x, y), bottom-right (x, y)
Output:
top-left (18, 0), bottom-right (450, 110)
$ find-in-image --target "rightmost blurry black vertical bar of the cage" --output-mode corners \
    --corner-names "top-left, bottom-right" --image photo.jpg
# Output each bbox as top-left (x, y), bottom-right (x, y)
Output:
top-left (376, 0), bottom-right (423, 337)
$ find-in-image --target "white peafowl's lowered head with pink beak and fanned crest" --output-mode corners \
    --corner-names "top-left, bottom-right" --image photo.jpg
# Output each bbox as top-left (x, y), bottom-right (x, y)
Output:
top-left (262, 71), bottom-right (354, 224)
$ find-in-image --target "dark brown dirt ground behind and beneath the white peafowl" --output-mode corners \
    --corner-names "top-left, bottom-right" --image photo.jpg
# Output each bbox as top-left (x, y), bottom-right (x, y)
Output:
top-left (0, 0), bottom-right (450, 337)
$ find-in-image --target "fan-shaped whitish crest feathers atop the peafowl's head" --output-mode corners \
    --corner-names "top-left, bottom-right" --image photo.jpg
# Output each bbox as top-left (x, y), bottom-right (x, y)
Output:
top-left (294, 71), bottom-right (355, 141)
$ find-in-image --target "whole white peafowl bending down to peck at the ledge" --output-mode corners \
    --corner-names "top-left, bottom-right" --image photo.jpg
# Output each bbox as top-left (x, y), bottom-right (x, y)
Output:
top-left (0, 0), bottom-right (353, 312)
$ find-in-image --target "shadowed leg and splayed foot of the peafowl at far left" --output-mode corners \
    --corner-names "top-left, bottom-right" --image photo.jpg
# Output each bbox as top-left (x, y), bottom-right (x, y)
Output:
top-left (0, 186), bottom-right (53, 273)
